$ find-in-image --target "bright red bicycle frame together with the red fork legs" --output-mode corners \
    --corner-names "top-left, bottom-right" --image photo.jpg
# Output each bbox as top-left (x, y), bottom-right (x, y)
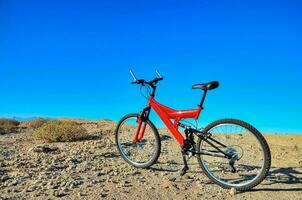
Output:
top-left (133, 96), bottom-right (202, 146)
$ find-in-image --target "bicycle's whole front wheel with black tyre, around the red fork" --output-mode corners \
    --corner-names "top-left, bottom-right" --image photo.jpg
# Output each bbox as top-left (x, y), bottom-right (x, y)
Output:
top-left (115, 114), bottom-right (161, 168)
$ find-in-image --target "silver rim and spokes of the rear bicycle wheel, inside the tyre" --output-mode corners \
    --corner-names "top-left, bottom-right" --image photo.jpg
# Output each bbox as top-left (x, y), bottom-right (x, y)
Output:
top-left (200, 123), bottom-right (265, 187)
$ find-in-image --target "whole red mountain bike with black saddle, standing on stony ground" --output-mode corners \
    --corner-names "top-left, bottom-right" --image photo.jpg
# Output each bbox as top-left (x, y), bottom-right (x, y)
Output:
top-left (115, 70), bottom-right (271, 191)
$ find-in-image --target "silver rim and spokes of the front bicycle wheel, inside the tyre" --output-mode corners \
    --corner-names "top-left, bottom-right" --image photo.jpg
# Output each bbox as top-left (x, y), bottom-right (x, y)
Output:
top-left (117, 117), bottom-right (158, 166)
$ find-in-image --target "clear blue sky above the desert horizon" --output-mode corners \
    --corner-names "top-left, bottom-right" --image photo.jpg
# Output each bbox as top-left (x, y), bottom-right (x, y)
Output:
top-left (0, 0), bottom-right (302, 133)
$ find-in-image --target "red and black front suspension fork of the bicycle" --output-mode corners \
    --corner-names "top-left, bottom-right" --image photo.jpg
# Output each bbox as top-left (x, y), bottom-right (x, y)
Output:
top-left (133, 107), bottom-right (151, 144)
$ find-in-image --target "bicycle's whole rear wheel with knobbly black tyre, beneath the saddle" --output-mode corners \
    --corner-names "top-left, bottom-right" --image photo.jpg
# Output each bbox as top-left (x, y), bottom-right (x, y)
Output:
top-left (196, 119), bottom-right (271, 191)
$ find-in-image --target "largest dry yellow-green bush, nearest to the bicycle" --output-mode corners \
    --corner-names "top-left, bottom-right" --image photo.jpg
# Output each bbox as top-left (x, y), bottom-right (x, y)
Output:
top-left (33, 120), bottom-right (88, 142)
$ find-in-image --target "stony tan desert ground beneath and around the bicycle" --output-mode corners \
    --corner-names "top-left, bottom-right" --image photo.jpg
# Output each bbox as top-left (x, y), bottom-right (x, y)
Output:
top-left (0, 120), bottom-right (302, 200)
